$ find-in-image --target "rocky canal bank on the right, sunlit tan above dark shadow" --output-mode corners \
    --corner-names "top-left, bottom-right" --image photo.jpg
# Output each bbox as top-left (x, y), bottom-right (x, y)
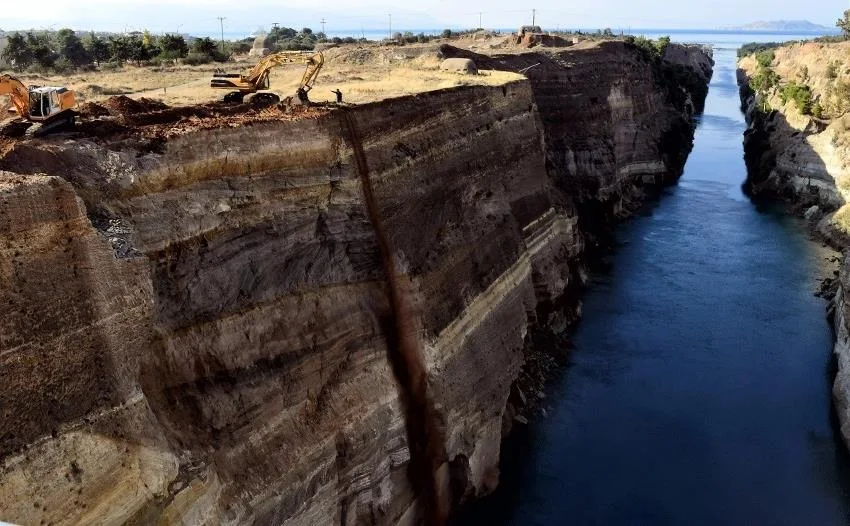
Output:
top-left (738, 49), bottom-right (850, 447)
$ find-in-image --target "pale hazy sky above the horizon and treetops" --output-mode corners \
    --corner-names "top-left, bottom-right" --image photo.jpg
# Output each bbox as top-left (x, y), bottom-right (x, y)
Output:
top-left (0, 0), bottom-right (850, 36)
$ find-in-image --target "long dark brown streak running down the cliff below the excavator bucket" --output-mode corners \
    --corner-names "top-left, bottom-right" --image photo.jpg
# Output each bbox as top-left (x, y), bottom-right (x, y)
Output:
top-left (340, 110), bottom-right (448, 525)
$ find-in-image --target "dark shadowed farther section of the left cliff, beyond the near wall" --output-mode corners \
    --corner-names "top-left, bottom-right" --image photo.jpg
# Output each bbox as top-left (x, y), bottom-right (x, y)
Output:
top-left (443, 41), bottom-right (714, 252)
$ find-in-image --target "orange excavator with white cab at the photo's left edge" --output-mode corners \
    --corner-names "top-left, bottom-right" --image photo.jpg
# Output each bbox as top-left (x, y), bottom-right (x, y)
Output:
top-left (0, 74), bottom-right (77, 136)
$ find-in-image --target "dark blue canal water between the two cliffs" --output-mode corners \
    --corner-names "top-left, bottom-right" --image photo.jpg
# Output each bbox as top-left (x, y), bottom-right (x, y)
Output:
top-left (456, 35), bottom-right (850, 526)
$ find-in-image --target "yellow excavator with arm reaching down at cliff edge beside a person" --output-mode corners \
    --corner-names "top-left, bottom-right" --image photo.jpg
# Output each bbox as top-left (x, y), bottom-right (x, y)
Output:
top-left (210, 51), bottom-right (325, 104)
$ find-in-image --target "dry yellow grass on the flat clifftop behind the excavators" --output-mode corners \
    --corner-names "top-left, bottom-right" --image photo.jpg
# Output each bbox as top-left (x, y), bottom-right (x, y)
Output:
top-left (1, 45), bottom-right (523, 112)
